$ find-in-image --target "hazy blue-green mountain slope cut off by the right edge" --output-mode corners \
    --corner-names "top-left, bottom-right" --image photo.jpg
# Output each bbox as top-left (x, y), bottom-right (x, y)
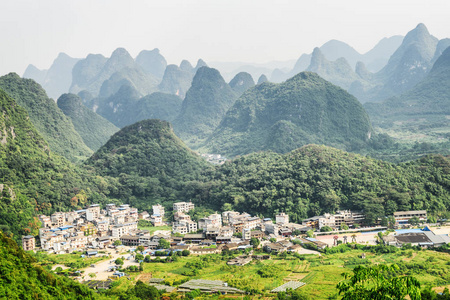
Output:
top-left (364, 45), bottom-right (450, 154)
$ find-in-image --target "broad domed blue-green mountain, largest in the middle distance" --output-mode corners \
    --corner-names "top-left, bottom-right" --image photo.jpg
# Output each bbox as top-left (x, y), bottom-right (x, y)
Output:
top-left (205, 72), bottom-right (372, 156)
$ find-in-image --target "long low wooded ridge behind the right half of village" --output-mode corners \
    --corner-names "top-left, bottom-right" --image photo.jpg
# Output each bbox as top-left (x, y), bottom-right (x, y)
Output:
top-left (205, 145), bottom-right (450, 223)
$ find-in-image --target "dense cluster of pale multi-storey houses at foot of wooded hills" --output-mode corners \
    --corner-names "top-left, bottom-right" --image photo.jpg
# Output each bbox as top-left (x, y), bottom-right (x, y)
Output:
top-left (22, 202), bottom-right (436, 254)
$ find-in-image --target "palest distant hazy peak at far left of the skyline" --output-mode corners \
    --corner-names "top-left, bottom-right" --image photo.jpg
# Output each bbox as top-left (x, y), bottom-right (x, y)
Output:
top-left (23, 53), bottom-right (80, 100)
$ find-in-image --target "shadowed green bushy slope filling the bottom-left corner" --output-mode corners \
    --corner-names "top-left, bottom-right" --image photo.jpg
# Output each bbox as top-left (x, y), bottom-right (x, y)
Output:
top-left (0, 232), bottom-right (94, 299)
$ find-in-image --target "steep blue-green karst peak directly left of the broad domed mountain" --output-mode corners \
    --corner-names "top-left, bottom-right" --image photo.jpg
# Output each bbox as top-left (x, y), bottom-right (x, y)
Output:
top-left (173, 67), bottom-right (237, 145)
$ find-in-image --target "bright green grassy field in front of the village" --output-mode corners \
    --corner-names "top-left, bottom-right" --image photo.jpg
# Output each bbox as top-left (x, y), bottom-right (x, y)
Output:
top-left (100, 246), bottom-right (450, 299)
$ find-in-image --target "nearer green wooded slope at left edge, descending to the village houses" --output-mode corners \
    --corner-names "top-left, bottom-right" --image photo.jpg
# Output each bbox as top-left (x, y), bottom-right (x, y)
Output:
top-left (0, 90), bottom-right (108, 239)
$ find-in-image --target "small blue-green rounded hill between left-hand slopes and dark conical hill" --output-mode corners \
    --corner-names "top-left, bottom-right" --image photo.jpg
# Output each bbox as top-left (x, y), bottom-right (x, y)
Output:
top-left (57, 94), bottom-right (119, 151)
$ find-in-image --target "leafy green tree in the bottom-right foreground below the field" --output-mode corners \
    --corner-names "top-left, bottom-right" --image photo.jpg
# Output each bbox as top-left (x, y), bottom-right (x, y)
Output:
top-left (337, 264), bottom-right (421, 300)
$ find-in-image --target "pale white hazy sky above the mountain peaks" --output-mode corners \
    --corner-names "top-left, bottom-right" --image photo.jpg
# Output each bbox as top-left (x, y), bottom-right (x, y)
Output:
top-left (0, 0), bottom-right (450, 75)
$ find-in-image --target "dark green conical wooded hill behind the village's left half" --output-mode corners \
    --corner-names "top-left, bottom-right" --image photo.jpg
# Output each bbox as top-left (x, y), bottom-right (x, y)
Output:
top-left (86, 120), bottom-right (211, 207)
